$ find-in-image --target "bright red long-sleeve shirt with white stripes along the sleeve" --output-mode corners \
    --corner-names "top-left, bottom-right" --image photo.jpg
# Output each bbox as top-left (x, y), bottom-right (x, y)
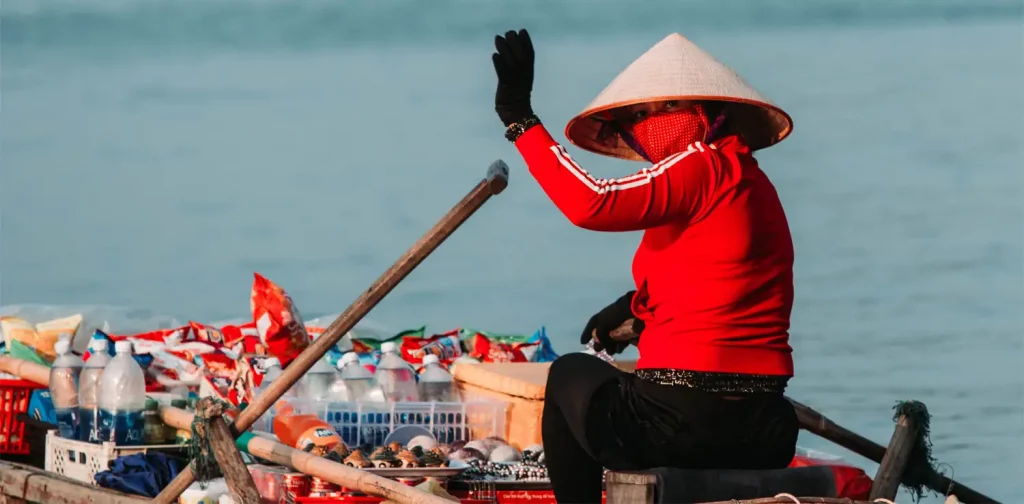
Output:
top-left (516, 126), bottom-right (793, 376)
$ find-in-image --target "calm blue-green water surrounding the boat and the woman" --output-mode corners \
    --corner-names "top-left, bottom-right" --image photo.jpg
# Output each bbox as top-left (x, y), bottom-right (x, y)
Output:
top-left (0, 0), bottom-right (1024, 502)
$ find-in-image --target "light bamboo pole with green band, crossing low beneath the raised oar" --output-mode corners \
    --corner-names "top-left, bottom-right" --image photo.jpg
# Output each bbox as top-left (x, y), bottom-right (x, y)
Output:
top-left (0, 355), bottom-right (451, 504)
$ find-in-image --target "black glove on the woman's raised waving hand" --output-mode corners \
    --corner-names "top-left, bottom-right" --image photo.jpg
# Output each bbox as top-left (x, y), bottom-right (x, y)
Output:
top-left (490, 30), bottom-right (534, 127)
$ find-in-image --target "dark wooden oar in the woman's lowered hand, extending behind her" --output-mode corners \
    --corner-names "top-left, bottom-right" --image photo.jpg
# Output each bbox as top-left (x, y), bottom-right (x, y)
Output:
top-left (610, 319), bottom-right (997, 502)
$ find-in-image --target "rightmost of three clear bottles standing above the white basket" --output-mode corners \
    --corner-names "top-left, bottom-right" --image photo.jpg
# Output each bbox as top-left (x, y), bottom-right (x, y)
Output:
top-left (98, 341), bottom-right (145, 446)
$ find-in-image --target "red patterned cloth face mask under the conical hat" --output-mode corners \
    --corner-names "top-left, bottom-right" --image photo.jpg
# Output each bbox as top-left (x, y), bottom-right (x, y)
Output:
top-left (631, 103), bottom-right (709, 163)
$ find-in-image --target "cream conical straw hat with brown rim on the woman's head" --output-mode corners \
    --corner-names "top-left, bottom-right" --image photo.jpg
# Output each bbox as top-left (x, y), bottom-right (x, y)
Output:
top-left (565, 33), bottom-right (793, 161)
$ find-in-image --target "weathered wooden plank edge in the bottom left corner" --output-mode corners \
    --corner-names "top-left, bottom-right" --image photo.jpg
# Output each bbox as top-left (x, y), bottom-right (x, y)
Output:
top-left (0, 462), bottom-right (150, 504)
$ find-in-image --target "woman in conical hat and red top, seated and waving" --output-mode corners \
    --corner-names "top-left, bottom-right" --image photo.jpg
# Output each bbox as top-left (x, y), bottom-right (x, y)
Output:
top-left (493, 30), bottom-right (798, 503)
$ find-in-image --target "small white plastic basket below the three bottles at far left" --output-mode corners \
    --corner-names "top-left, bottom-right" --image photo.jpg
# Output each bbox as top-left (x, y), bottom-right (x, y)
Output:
top-left (45, 430), bottom-right (181, 485)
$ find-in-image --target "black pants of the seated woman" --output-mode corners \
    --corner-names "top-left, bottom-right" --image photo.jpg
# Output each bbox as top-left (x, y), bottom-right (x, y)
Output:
top-left (542, 353), bottom-right (799, 503)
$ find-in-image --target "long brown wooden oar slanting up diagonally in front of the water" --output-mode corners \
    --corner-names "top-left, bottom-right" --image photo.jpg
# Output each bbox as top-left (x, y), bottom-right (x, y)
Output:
top-left (156, 160), bottom-right (509, 504)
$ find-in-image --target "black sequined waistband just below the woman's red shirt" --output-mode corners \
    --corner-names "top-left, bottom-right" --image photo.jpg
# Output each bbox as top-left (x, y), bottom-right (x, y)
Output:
top-left (634, 369), bottom-right (790, 393)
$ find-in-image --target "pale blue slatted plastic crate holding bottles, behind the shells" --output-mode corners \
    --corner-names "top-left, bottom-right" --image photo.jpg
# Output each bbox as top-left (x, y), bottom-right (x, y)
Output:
top-left (255, 402), bottom-right (506, 447)
